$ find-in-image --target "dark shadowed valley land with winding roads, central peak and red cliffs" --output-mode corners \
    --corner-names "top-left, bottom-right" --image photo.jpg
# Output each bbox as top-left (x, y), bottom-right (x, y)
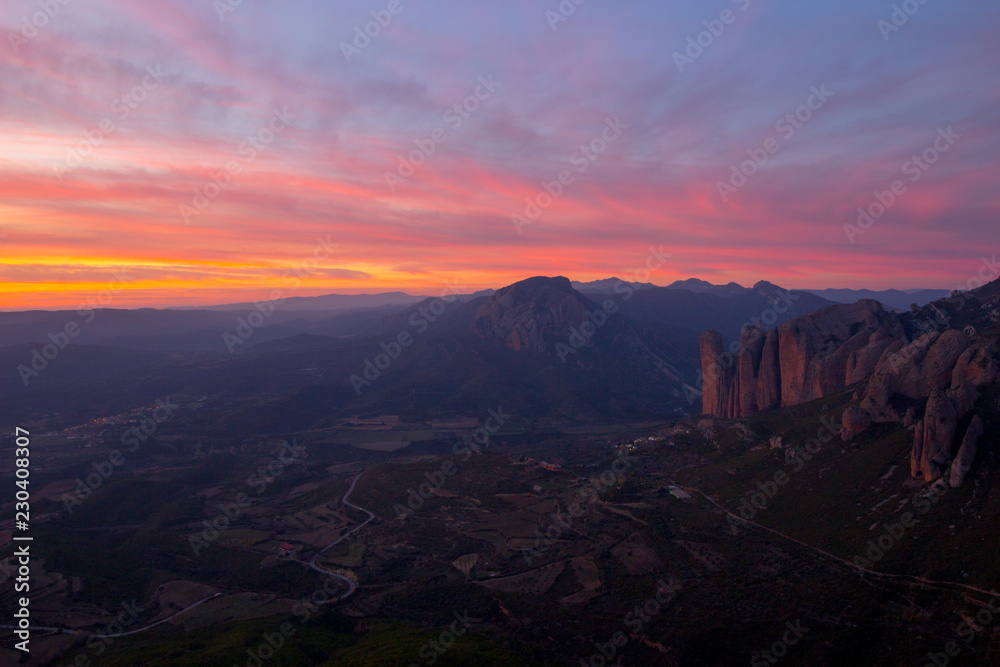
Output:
top-left (0, 278), bottom-right (1000, 667)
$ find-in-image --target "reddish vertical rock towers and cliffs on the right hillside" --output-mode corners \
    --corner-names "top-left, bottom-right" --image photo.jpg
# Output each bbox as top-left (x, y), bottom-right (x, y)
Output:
top-left (701, 281), bottom-right (1000, 486)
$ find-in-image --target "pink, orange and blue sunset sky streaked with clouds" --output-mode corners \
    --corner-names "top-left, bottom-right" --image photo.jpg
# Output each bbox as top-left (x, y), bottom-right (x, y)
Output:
top-left (0, 0), bottom-right (1000, 310)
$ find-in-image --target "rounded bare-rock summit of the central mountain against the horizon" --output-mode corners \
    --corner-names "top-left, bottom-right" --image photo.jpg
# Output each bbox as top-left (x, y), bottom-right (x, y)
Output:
top-left (472, 277), bottom-right (587, 352)
